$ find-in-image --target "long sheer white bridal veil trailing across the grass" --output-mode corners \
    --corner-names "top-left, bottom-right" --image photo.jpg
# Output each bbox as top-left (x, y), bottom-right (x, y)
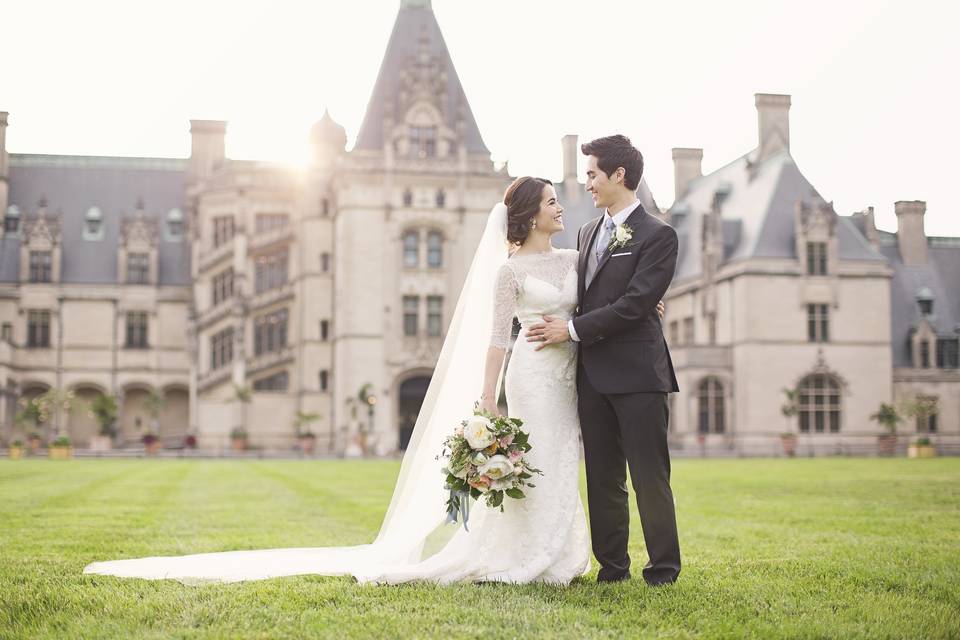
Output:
top-left (84, 203), bottom-right (508, 583)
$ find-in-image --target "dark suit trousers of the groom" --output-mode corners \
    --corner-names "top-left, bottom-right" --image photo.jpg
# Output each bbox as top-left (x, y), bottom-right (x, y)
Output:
top-left (577, 358), bottom-right (680, 584)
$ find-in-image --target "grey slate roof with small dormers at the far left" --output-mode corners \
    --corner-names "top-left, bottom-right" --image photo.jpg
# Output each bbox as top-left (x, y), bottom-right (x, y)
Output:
top-left (0, 154), bottom-right (190, 285)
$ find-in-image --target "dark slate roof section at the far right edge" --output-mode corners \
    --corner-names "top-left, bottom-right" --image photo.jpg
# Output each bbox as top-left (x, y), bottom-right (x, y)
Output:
top-left (880, 232), bottom-right (960, 367)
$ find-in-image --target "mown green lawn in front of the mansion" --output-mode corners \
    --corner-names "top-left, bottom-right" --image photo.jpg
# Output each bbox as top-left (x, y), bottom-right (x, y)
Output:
top-left (0, 458), bottom-right (960, 638)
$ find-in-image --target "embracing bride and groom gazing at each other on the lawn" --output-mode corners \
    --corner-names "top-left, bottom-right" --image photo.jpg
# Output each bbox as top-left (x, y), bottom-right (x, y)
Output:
top-left (84, 135), bottom-right (680, 585)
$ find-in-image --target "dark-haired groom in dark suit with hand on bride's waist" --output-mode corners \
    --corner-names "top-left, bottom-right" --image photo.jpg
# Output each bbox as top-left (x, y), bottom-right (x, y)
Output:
top-left (527, 135), bottom-right (680, 585)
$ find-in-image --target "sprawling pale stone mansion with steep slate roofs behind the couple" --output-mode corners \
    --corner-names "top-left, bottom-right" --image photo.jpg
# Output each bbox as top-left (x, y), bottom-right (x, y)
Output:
top-left (0, 0), bottom-right (960, 454)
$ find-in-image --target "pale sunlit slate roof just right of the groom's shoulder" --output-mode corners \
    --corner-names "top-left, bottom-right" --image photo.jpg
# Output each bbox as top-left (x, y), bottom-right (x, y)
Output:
top-left (670, 150), bottom-right (883, 281)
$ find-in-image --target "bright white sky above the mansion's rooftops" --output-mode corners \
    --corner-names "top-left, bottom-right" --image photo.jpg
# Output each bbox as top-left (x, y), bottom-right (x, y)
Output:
top-left (0, 0), bottom-right (960, 236)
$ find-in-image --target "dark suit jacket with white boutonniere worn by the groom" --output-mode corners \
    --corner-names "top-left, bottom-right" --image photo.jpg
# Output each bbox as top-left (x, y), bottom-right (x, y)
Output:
top-left (573, 205), bottom-right (679, 393)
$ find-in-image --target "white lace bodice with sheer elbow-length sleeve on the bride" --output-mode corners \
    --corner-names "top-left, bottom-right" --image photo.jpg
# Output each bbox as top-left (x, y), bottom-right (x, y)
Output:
top-left (490, 249), bottom-right (579, 349)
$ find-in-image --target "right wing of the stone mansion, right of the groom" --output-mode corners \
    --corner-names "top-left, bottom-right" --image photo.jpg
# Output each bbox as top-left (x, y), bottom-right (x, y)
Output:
top-left (663, 94), bottom-right (960, 455)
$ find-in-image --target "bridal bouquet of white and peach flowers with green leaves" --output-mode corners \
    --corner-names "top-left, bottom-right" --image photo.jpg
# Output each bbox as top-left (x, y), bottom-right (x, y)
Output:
top-left (438, 408), bottom-right (543, 531)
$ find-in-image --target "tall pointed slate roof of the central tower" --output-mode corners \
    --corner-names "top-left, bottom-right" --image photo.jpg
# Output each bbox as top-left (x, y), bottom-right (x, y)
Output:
top-left (354, 2), bottom-right (490, 155)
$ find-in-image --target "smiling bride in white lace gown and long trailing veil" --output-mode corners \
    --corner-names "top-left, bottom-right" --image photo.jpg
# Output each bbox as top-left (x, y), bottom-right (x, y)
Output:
top-left (84, 176), bottom-right (652, 584)
